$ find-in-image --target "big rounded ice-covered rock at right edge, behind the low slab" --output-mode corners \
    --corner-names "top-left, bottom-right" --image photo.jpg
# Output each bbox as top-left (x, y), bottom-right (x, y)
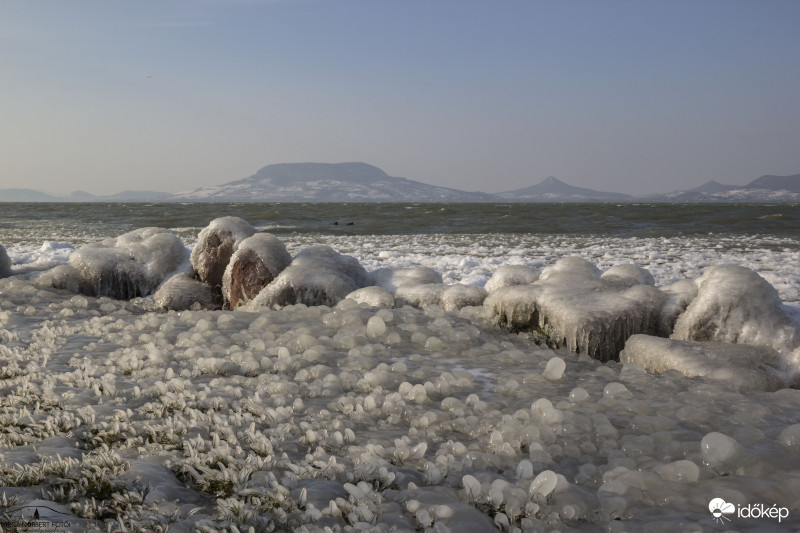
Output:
top-left (672, 265), bottom-right (800, 354)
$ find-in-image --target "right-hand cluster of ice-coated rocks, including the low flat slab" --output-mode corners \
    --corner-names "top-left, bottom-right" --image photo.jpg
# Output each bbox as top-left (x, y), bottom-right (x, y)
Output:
top-left (484, 257), bottom-right (800, 378)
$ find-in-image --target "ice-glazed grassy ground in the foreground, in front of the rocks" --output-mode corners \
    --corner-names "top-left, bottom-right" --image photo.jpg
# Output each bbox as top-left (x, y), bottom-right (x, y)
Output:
top-left (0, 274), bottom-right (800, 532)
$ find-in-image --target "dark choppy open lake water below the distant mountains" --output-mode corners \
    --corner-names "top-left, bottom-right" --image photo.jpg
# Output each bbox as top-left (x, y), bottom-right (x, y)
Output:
top-left (0, 203), bottom-right (800, 244)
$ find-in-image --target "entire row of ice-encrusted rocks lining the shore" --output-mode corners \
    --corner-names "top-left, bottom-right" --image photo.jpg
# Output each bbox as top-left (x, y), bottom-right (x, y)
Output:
top-left (28, 217), bottom-right (800, 387)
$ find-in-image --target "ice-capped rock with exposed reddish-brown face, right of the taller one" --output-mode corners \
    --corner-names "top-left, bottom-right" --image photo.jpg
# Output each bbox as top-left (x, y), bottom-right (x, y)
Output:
top-left (222, 233), bottom-right (292, 309)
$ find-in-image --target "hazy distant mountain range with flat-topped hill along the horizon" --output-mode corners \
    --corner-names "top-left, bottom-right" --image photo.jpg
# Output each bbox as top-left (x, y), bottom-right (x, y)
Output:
top-left (0, 163), bottom-right (800, 203)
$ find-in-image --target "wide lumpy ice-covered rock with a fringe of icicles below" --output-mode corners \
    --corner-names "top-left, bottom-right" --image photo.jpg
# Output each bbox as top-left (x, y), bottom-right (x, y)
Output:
top-left (484, 257), bottom-right (665, 361)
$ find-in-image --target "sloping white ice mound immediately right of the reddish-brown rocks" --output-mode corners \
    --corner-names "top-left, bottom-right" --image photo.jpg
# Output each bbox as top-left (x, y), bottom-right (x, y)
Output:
top-left (247, 244), bottom-right (369, 309)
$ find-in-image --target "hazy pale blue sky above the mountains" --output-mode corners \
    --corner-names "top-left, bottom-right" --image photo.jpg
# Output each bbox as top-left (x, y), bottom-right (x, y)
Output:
top-left (0, 0), bottom-right (800, 194)
